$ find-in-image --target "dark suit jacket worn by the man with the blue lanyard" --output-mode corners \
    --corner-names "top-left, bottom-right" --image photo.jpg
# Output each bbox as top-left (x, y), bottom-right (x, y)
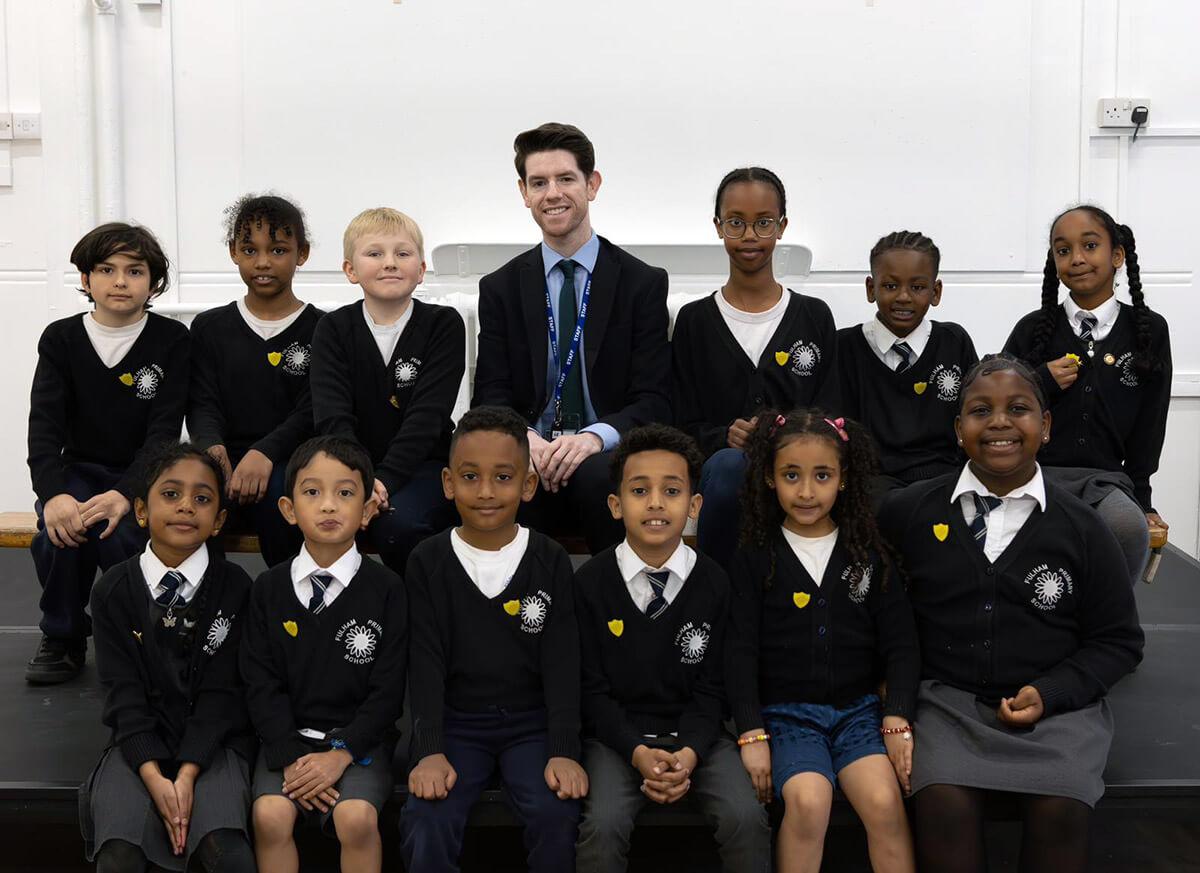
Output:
top-left (472, 236), bottom-right (671, 434)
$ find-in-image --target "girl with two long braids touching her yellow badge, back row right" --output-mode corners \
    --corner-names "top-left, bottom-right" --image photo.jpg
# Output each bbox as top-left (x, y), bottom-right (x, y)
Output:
top-left (1004, 205), bottom-right (1171, 582)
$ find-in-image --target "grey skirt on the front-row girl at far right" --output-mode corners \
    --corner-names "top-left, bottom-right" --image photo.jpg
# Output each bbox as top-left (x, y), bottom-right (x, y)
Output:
top-left (912, 680), bottom-right (1112, 806)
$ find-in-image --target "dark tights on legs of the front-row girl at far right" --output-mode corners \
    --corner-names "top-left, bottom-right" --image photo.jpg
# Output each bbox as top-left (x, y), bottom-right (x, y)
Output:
top-left (913, 784), bottom-right (1092, 873)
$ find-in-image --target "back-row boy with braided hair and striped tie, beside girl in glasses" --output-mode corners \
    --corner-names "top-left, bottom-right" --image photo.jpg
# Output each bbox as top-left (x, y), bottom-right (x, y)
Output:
top-left (838, 230), bottom-right (979, 499)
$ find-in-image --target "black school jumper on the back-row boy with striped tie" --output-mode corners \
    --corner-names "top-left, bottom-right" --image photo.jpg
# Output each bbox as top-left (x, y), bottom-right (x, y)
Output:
top-left (838, 321), bottom-right (979, 483)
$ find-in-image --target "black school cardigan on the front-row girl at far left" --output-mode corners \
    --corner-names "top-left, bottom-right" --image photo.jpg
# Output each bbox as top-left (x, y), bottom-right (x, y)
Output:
top-left (91, 552), bottom-right (254, 772)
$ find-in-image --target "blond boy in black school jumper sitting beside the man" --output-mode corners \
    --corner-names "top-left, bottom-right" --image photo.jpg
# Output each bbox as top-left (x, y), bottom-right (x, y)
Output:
top-left (312, 209), bottom-right (467, 573)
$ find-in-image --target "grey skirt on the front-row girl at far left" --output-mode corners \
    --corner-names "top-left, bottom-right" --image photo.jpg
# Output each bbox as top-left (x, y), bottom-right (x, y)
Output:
top-left (79, 746), bottom-right (250, 871)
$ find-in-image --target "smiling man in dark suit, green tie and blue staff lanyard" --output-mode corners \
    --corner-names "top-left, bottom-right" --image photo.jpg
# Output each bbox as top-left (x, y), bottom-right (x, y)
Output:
top-left (472, 124), bottom-right (671, 552)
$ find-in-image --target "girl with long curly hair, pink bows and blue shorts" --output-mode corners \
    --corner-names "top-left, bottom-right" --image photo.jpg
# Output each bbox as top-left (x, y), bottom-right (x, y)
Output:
top-left (726, 409), bottom-right (920, 873)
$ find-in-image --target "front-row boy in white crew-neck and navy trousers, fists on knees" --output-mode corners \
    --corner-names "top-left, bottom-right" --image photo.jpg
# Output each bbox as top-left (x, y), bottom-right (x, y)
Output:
top-left (400, 407), bottom-right (588, 873)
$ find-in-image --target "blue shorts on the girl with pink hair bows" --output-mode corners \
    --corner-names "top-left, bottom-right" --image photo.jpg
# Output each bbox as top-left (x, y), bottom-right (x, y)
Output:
top-left (762, 694), bottom-right (887, 796)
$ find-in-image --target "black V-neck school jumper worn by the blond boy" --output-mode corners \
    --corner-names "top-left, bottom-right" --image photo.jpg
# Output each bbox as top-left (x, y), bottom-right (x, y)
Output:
top-left (311, 299), bottom-right (467, 494)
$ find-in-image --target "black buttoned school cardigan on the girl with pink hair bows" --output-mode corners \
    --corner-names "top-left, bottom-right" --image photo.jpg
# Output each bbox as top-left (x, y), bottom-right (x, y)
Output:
top-left (726, 530), bottom-right (920, 733)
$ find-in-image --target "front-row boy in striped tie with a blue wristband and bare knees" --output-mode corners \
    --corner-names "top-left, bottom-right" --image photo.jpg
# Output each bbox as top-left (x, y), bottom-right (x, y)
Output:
top-left (241, 437), bottom-right (408, 873)
